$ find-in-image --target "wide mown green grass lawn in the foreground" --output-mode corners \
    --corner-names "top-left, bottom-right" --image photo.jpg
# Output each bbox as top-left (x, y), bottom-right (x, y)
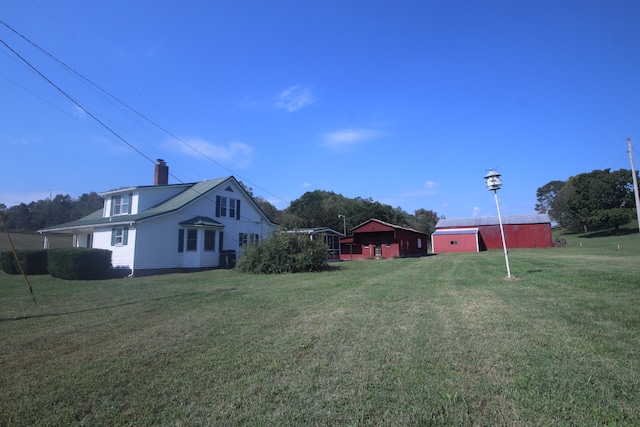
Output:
top-left (0, 229), bottom-right (640, 426)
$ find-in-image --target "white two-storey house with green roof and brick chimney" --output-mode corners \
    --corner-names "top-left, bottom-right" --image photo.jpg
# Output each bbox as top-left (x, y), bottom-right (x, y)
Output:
top-left (38, 160), bottom-right (275, 275)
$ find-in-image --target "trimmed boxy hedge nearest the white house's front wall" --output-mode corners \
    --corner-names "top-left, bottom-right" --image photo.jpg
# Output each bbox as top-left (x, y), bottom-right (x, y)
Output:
top-left (48, 248), bottom-right (111, 280)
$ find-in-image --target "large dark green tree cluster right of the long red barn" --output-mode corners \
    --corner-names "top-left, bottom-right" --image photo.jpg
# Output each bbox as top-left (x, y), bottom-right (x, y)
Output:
top-left (535, 169), bottom-right (636, 232)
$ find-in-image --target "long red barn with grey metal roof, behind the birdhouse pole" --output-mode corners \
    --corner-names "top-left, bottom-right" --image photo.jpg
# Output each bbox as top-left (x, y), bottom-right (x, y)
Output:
top-left (431, 215), bottom-right (553, 253)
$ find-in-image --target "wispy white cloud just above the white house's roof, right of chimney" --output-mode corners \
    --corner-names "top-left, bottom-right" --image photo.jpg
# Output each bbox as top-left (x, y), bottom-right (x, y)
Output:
top-left (171, 138), bottom-right (253, 168)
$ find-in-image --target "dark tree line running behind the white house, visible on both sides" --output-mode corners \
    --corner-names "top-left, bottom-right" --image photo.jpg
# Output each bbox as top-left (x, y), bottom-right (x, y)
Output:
top-left (0, 187), bottom-right (440, 234)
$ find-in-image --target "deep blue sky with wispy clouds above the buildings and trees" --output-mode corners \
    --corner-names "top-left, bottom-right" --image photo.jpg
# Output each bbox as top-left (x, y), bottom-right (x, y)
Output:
top-left (0, 0), bottom-right (640, 218)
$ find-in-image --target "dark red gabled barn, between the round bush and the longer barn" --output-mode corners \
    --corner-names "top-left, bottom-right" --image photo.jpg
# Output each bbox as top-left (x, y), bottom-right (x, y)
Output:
top-left (340, 219), bottom-right (428, 261)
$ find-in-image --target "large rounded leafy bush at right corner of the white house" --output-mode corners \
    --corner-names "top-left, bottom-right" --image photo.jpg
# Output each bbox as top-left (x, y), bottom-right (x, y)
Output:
top-left (236, 233), bottom-right (328, 273)
